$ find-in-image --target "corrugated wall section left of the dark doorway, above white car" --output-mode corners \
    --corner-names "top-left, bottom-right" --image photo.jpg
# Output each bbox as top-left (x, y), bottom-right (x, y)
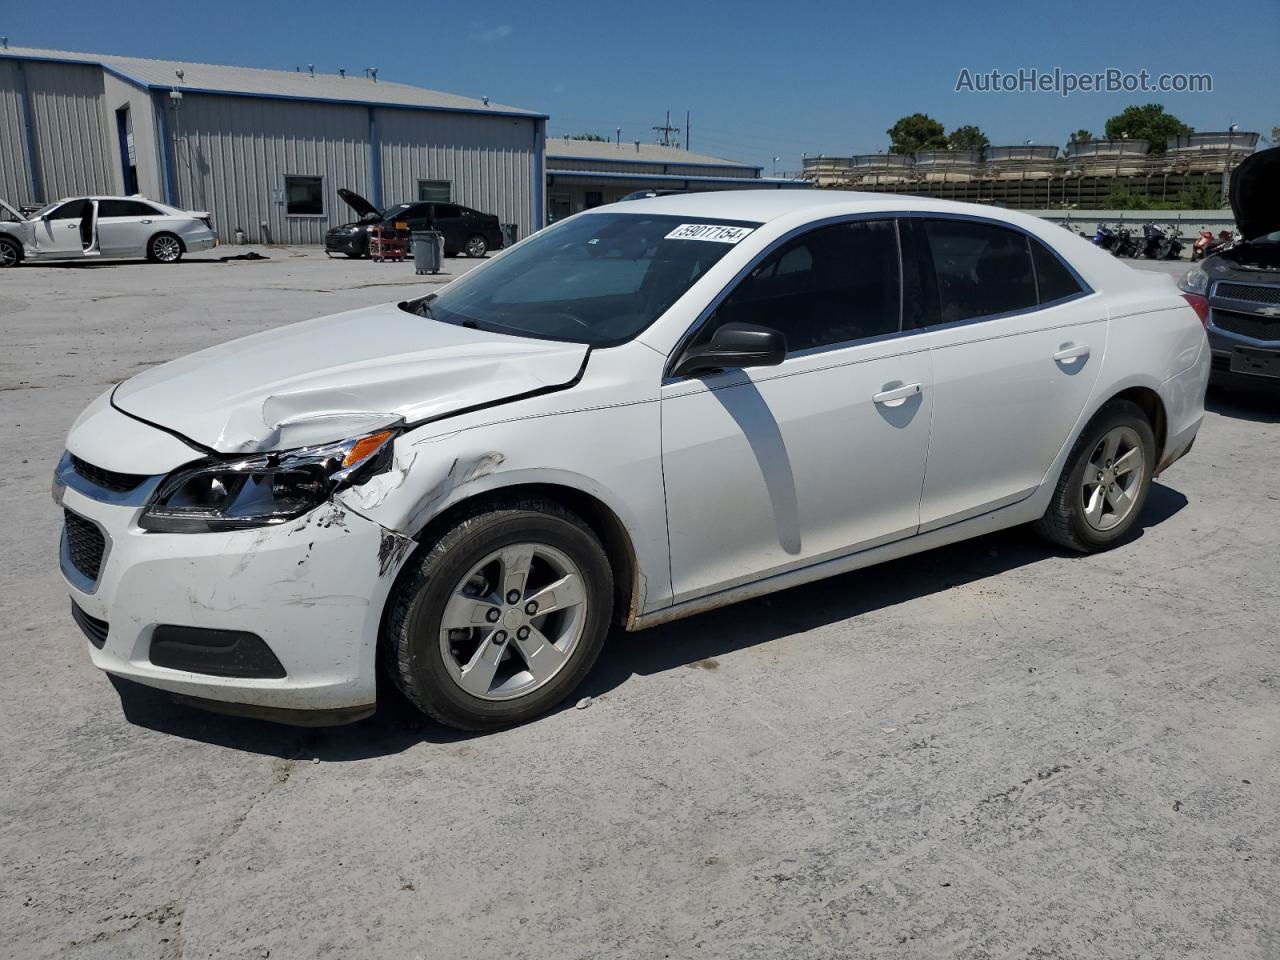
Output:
top-left (24, 61), bottom-right (114, 200)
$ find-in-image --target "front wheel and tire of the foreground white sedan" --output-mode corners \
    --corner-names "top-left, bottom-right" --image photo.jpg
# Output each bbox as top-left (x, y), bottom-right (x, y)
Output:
top-left (381, 499), bottom-right (613, 730)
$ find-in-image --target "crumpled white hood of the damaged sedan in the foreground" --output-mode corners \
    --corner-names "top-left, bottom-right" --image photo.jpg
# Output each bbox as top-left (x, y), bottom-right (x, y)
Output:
top-left (111, 303), bottom-right (588, 453)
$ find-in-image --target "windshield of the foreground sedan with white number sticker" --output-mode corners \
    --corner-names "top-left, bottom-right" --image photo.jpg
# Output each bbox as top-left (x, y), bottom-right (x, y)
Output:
top-left (404, 214), bottom-right (759, 347)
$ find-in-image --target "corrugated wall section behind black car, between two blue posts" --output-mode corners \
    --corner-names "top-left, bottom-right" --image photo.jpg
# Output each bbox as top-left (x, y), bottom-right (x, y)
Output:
top-left (376, 109), bottom-right (538, 237)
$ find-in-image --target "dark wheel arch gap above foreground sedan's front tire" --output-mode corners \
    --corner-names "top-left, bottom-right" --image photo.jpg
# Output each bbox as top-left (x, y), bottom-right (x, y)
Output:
top-left (413, 481), bottom-right (644, 628)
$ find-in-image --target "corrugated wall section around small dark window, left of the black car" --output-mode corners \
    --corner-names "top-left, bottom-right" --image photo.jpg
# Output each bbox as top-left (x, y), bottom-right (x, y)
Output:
top-left (168, 93), bottom-right (372, 243)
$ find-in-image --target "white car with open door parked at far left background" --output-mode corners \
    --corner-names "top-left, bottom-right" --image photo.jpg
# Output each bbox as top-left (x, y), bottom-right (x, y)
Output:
top-left (0, 197), bottom-right (218, 268)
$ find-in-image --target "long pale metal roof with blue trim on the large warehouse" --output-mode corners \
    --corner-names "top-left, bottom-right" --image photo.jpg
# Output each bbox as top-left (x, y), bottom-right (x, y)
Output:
top-left (0, 47), bottom-right (545, 116)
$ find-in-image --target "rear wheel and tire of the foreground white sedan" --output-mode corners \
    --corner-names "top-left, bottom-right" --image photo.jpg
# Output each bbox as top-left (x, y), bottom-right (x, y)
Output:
top-left (1033, 399), bottom-right (1156, 553)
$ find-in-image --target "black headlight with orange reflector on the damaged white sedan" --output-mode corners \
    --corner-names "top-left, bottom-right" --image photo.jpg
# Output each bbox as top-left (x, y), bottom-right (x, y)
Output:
top-left (138, 430), bottom-right (397, 534)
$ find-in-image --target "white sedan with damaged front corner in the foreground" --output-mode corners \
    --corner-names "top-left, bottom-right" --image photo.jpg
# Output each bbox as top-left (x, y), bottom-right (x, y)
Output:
top-left (54, 191), bottom-right (1210, 730)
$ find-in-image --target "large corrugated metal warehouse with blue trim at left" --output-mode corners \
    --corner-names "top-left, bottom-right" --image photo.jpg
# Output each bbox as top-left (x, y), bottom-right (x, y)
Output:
top-left (0, 47), bottom-right (547, 243)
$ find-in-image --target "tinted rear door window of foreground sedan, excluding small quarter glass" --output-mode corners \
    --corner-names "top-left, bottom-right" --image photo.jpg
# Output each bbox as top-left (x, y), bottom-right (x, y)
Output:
top-left (923, 220), bottom-right (1039, 324)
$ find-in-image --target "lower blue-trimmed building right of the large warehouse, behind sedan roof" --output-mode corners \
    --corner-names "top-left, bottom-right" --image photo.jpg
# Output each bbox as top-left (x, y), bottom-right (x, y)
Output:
top-left (547, 140), bottom-right (810, 220)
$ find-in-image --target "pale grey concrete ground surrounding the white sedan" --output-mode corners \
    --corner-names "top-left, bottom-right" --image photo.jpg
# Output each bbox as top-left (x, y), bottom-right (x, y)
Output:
top-left (0, 250), bottom-right (1280, 960)
